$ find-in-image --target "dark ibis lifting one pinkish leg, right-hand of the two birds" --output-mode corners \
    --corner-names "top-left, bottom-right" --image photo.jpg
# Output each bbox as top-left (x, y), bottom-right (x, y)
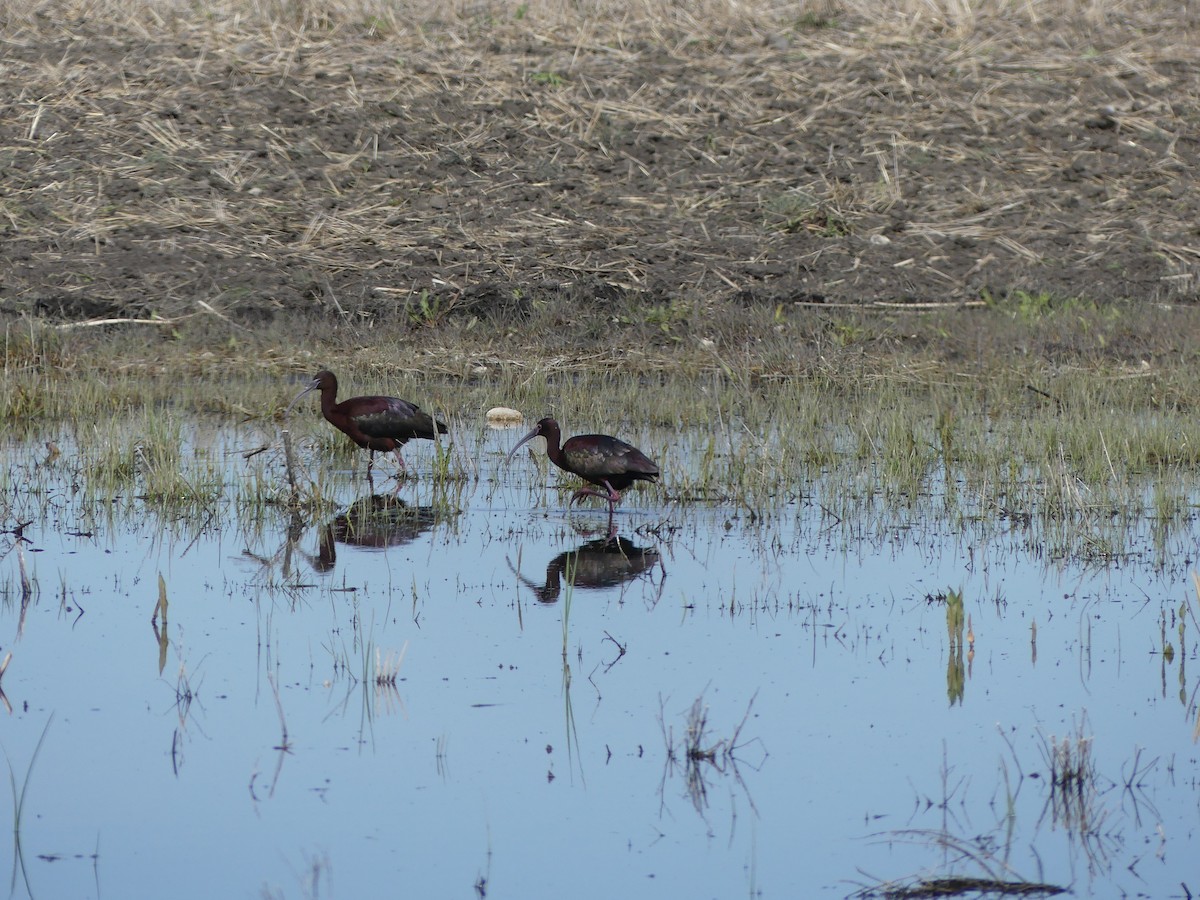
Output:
top-left (509, 416), bottom-right (659, 515)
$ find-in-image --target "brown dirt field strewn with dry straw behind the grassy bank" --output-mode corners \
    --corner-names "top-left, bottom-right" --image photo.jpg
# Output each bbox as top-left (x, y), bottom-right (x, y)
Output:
top-left (0, 2), bottom-right (1200, 360)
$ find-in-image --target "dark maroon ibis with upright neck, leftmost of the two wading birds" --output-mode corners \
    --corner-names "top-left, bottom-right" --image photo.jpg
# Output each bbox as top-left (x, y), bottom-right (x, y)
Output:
top-left (284, 370), bottom-right (446, 474)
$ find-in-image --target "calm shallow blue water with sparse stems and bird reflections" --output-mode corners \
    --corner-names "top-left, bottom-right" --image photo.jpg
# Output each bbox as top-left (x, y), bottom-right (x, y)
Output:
top-left (0, 426), bottom-right (1200, 898)
